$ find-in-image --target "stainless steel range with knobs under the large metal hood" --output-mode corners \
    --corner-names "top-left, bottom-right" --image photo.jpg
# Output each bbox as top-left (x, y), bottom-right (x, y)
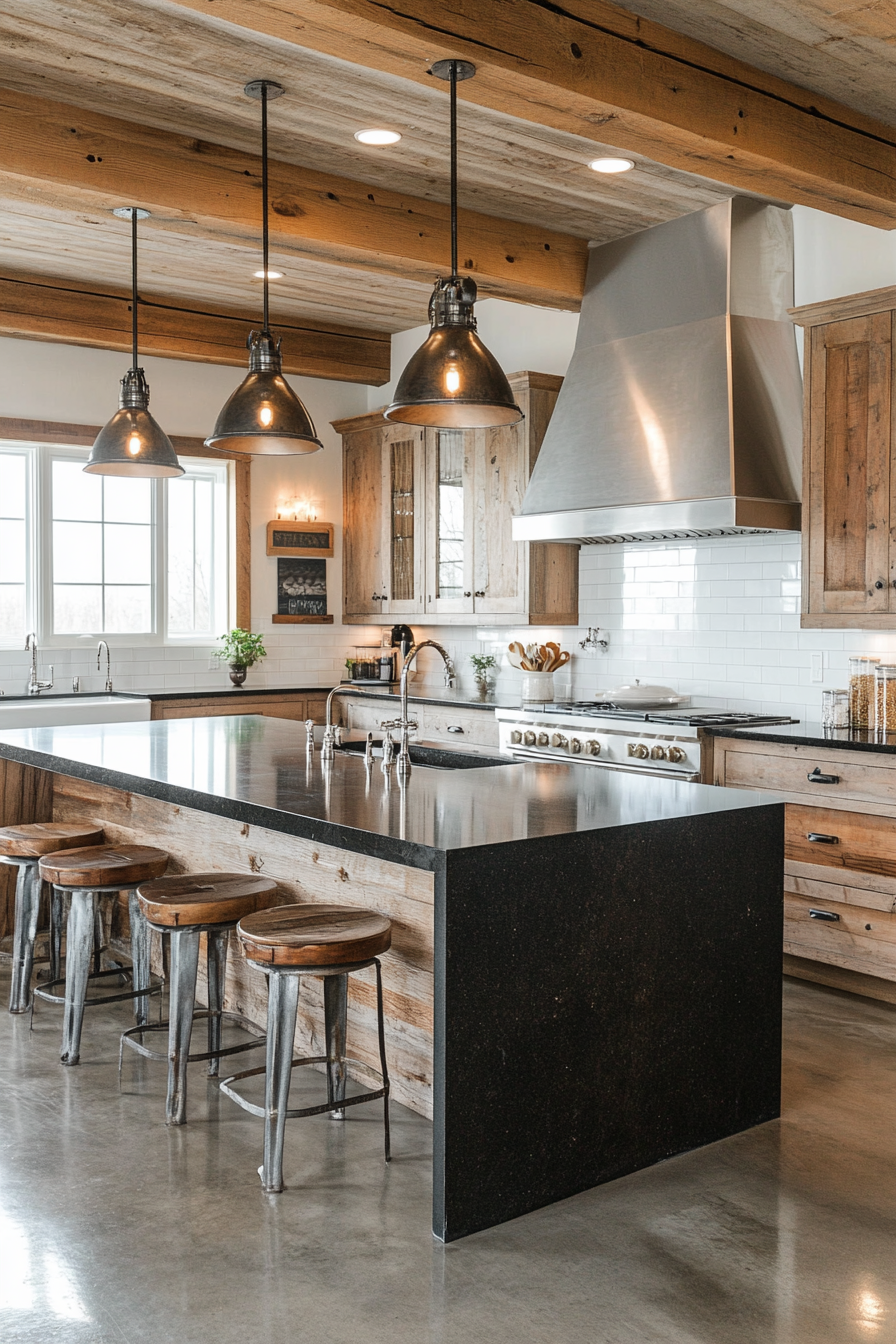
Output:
top-left (496, 700), bottom-right (798, 781)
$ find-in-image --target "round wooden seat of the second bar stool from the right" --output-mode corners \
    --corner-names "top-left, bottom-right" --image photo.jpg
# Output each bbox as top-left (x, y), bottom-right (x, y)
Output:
top-left (137, 872), bottom-right (277, 929)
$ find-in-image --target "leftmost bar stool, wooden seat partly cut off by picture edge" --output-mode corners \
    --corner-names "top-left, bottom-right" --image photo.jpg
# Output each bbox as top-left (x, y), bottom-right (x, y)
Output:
top-left (0, 821), bottom-right (103, 1012)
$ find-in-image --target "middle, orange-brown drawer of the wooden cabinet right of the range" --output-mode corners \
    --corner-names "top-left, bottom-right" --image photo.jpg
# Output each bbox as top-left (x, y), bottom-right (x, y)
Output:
top-left (785, 802), bottom-right (896, 882)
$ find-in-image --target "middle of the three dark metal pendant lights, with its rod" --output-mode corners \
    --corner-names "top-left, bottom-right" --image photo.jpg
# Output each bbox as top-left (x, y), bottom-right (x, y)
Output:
top-left (206, 79), bottom-right (324, 457)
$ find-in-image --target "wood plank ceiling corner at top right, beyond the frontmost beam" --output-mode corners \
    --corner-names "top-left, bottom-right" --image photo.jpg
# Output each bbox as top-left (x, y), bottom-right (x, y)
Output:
top-left (617, 0), bottom-right (896, 125)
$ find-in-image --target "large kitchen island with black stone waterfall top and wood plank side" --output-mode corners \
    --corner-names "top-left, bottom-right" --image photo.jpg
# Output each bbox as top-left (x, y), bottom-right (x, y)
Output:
top-left (0, 716), bottom-right (783, 1241)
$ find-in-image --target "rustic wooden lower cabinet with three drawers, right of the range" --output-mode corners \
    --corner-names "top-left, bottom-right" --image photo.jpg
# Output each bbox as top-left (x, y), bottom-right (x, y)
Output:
top-left (704, 738), bottom-right (896, 1003)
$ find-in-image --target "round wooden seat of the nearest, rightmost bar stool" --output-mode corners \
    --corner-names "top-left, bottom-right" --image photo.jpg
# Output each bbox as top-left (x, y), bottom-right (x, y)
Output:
top-left (236, 905), bottom-right (392, 969)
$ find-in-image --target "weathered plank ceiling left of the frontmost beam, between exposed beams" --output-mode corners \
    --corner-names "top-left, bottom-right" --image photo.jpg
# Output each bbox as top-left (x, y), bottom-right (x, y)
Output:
top-left (0, 0), bottom-right (731, 331)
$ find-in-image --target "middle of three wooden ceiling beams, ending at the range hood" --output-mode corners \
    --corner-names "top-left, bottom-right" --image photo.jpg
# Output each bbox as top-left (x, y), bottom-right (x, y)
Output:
top-left (0, 89), bottom-right (587, 311)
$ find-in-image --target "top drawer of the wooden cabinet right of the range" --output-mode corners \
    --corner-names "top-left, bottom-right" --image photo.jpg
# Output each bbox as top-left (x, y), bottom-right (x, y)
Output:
top-left (719, 743), bottom-right (896, 806)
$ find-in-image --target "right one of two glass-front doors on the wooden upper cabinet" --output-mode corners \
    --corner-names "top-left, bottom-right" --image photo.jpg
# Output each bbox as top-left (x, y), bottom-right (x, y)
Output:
top-left (426, 429), bottom-right (473, 614)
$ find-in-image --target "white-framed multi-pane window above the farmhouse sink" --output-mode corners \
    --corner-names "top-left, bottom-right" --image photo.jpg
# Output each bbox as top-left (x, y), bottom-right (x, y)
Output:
top-left (0, 442), bottom-right (232, 648)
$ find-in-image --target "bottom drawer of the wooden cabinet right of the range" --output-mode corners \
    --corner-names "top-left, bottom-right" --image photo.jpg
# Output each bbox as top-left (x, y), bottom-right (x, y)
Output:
top-left (785, 892), bottom-right (896, 980)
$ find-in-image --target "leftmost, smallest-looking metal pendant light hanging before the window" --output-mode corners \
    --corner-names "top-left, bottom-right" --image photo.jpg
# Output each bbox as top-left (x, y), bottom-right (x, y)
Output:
top-left (85, 206), bottom-right (184, 476)
